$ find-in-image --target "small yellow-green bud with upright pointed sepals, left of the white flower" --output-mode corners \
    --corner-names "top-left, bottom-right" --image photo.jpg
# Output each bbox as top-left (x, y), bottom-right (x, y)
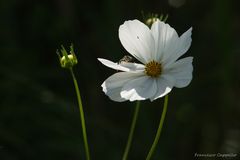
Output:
top-left (57, 45), bottom-right (78, 69)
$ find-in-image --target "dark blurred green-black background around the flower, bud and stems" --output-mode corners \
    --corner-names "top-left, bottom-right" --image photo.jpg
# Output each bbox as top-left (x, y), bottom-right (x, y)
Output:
top-left (0, 0), bottom-right (240, 160)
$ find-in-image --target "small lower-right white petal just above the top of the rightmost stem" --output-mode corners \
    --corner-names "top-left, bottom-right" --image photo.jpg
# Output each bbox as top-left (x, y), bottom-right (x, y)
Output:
top-left (150, 75), bottom-right (175, 101)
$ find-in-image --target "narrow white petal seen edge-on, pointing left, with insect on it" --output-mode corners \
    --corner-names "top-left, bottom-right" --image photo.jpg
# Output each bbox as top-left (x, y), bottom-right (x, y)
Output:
top-left (98, 58), bottom-right (144, 72)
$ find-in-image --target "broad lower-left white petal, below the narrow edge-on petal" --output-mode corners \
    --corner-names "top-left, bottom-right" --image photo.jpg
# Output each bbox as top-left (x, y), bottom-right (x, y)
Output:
top-left (102, 72), bottom-right (143, 102)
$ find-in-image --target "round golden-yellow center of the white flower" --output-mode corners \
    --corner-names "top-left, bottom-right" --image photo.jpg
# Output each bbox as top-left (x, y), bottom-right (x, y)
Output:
top-left (145, 61), bottom-right (162, 78)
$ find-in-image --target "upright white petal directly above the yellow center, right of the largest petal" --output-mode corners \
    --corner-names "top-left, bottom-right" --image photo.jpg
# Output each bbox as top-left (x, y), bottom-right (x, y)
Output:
top-left (151, 20), bottom-right (179, 63)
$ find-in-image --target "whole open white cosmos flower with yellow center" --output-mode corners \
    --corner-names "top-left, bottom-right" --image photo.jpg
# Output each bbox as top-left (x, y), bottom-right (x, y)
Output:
top-left (98, 20), bottom-right (193, 102)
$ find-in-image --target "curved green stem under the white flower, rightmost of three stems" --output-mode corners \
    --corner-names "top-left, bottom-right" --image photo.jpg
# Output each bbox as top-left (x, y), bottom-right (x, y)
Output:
top-left (146, 95), bottom-right (168, 160)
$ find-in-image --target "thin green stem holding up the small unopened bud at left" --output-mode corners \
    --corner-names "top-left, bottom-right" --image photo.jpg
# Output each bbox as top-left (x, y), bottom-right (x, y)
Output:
top-left (70, 68), bottom-right (90, 160)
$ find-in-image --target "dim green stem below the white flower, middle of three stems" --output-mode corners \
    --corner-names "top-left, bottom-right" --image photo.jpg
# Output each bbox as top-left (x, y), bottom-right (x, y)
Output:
top-left (122, 101), bottom-right (140, 160)
